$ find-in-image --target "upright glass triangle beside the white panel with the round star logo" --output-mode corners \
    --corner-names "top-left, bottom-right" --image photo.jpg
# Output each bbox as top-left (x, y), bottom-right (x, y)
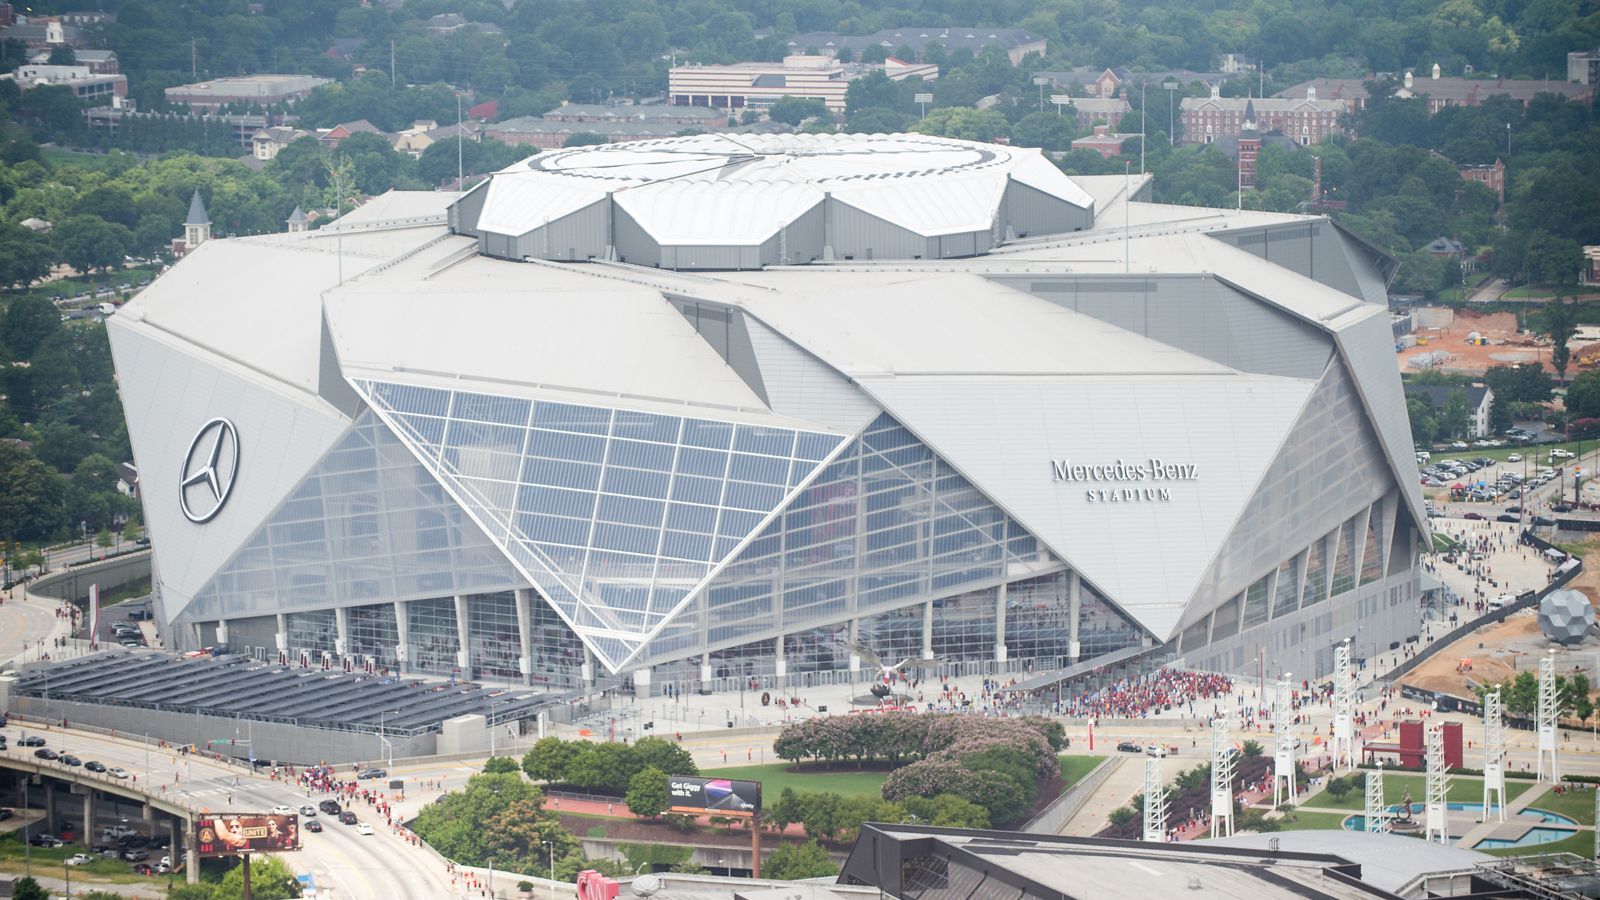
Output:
top-left (190, 412), bottom-right (526, 621)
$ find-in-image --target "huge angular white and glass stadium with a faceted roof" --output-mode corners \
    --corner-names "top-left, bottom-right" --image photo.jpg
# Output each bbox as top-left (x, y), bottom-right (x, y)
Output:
top-left (109, 135), bottom-right (1426, 695)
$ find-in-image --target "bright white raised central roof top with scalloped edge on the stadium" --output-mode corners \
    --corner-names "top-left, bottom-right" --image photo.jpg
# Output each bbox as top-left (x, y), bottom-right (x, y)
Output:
top-left (464, 135), bottom-right (1094, 245)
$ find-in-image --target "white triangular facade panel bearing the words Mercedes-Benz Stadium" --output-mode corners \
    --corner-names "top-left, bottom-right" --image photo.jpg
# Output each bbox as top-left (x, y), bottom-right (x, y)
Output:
top-left (862, 376), bottom-right (1312, 639)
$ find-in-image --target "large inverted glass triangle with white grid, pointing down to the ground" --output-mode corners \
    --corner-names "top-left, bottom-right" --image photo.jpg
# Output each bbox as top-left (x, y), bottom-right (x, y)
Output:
top-left (358, 381), bottom-right (845, 665)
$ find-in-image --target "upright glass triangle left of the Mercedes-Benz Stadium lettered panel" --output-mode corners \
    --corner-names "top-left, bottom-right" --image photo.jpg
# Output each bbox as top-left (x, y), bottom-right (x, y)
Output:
top-left (642, 415), bottom-right (1059, 661)
